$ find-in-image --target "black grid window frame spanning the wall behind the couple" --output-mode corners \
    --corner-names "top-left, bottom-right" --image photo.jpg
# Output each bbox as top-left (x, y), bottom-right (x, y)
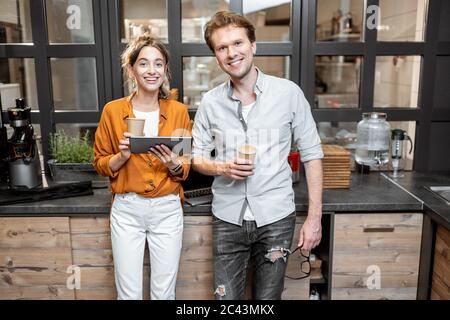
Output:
top-left (0, 0), bottom-right (450, 171)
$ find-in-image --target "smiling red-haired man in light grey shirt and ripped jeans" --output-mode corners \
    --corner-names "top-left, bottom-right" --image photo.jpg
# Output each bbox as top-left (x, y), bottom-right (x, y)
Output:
top-left (192, 12), bottom-right (323, 299)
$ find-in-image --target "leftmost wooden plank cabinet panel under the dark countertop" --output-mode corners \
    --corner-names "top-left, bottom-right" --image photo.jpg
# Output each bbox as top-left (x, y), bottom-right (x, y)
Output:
top-left (0, 217), bottom-right (74, 300)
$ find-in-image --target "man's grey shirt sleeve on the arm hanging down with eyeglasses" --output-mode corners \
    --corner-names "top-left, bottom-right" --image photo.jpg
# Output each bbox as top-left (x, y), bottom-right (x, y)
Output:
top-left (292, 87), bottom-right (323, 162)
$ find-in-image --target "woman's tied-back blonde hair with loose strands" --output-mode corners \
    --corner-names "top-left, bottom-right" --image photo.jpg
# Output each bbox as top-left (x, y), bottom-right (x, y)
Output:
top-left (121, 32), bottom-right (172, 99)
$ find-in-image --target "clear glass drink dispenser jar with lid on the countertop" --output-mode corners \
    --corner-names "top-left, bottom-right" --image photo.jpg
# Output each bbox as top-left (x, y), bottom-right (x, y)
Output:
top-left (355, 112), bottom-right (391, 166)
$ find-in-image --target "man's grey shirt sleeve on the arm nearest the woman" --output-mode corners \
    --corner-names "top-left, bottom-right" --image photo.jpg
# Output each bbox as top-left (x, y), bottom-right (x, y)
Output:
top-left (192, 99), bottom-right (214, 158)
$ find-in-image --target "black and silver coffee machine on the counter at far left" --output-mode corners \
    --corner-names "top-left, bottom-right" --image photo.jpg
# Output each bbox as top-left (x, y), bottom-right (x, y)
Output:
top-left (7, 99), bottom-right (42, 190)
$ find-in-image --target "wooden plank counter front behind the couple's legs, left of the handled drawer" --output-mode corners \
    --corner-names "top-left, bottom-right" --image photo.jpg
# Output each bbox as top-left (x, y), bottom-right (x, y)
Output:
top-left (0, 216), bottom-right (309, 300)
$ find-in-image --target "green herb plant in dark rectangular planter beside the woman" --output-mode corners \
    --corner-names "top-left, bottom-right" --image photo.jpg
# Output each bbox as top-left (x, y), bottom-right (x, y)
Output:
top-left (48, 130), bottom-right (107, 183)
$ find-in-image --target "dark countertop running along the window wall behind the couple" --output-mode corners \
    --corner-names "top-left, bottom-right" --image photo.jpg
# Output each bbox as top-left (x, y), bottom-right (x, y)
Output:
top-left (0, 173), bottom-right (423, 216)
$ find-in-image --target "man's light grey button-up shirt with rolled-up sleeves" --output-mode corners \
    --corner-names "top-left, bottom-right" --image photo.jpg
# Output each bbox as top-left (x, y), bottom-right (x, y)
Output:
top-left (192, 70), bottom-right (323, 227)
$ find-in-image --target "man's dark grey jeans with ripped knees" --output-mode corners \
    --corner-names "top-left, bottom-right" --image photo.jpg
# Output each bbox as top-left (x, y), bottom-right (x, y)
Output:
top-left (213, 212), bottom-right (296, 300)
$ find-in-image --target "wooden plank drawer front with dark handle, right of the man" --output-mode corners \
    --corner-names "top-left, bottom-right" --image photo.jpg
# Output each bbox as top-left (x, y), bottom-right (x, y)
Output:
top-left (331, 213), bottom-right (423, 300)
